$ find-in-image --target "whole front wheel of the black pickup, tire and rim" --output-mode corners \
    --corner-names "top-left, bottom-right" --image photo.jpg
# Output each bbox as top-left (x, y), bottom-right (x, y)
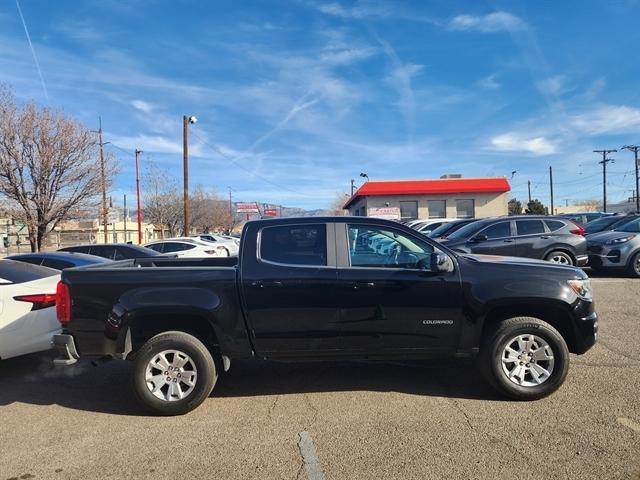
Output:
top-left (480, 317), bottom-right (569, 400)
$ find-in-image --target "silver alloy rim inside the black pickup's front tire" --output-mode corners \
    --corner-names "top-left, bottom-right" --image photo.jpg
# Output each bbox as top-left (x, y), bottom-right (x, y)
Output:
top-left (502, 334), bottom-right (555, 387)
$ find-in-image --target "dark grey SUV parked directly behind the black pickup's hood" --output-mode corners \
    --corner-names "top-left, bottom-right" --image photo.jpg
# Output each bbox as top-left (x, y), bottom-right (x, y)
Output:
top-left (442, 215), bottom-right (589, 266)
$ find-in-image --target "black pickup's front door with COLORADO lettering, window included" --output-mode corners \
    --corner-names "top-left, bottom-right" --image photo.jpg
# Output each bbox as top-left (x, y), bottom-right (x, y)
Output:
top-left (336, 222), bottom-right (463, 354)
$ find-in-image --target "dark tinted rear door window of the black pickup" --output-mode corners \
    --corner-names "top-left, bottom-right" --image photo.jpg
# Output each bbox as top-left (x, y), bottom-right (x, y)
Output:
top-left (260, 225), bottom-right (327, 265)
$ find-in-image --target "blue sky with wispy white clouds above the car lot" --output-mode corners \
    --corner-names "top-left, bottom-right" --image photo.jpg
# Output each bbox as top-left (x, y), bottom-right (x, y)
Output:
top-left (0, 0), bottom-right (640, 208)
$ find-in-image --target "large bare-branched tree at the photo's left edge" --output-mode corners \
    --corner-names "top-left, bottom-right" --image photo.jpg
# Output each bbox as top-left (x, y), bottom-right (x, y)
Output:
top-left (0, 85), bottom-right (116, 251)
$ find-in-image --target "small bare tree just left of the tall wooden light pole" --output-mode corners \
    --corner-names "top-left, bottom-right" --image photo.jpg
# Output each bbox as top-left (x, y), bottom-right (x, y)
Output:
top-left (142, 161), bottom-right (184, 237)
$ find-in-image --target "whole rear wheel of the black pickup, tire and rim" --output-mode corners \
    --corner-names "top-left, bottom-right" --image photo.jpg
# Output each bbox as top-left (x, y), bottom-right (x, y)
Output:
top-left (131, 332), bottom-right (218, 415)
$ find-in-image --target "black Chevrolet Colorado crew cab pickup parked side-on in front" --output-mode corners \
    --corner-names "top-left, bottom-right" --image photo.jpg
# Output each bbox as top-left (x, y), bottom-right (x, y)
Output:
top-left (54, 217), bottom-right (598, 415)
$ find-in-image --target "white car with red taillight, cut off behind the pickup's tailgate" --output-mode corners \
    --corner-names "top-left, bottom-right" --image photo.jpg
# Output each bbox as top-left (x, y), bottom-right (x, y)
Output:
top-left (0, 260), bottom-right (61, 360)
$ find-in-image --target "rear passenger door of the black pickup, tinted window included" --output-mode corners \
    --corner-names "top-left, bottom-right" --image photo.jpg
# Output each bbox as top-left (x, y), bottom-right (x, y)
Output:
top-left (240, 222), bottom-right (340, 358)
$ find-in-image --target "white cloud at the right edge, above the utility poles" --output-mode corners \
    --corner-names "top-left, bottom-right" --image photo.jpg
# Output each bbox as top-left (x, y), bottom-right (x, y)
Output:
top-left (571, 105), bottom-right (640, 135)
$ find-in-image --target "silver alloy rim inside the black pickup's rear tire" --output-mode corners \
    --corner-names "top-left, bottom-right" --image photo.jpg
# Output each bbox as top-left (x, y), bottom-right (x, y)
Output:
top-left (145, 350), bottom-right (198, 402)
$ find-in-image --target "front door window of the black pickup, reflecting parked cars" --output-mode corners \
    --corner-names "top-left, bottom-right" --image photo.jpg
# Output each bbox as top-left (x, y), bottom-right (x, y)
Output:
top-left (349, 225), bottom-right (433, 269)
